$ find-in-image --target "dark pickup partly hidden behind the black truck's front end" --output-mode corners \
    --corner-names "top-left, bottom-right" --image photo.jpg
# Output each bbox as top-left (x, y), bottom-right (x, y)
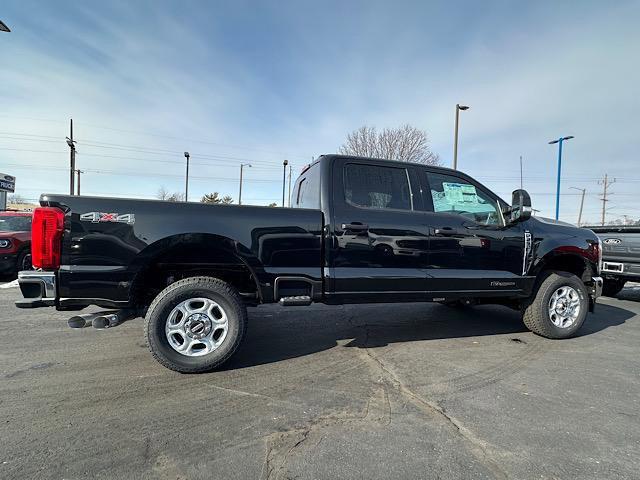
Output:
top-left (587, 225), bottom-right (640, 297)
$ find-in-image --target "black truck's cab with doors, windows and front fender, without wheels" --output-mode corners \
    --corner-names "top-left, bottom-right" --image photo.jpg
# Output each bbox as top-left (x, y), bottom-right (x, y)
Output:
top-left (292, 155), bottom-right (600, 303)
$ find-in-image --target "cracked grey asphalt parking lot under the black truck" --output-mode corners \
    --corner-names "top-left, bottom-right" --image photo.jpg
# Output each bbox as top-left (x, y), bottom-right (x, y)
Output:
top-left (0, 287), bottom-right (640, 479)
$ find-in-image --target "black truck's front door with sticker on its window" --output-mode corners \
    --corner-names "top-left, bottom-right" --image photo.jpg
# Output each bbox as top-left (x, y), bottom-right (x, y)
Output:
top-left (421, 170), bottom-right (529, 295)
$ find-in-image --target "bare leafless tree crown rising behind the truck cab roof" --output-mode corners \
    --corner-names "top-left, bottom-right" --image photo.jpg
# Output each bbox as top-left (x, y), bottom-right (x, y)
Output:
top-left (338, 124), bottom-right (440, 165)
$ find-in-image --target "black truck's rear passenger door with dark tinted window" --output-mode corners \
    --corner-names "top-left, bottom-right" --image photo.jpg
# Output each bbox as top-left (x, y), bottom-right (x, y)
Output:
top-left (327, 158), bottom-right (429, 301)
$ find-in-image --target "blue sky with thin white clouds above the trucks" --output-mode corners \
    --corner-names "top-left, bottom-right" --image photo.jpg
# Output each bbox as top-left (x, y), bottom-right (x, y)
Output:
top-left (0, 0), bottom-right (640, 223)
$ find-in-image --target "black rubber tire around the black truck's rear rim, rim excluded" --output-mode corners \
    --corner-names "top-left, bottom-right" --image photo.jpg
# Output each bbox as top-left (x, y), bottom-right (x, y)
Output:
top-left (144, 277), bottom-right (247, 373)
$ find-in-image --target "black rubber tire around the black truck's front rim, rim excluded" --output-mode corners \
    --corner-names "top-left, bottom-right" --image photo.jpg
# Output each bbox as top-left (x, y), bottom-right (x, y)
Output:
top-left (522, 271), bottom-right (589, 339)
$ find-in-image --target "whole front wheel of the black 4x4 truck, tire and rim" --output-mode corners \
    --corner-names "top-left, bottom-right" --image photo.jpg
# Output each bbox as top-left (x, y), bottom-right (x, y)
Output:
top-left (522, 272), bottom-right (589, 338)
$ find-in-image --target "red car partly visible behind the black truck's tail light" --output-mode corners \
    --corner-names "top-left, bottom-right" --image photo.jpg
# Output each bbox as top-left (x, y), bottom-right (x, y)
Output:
top-left (0, 211), bottom-right (33, 274)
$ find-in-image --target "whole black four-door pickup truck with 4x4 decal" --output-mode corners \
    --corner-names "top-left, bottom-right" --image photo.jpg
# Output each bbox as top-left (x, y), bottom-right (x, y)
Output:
top-left (17, 155), bottom-right (602, 372)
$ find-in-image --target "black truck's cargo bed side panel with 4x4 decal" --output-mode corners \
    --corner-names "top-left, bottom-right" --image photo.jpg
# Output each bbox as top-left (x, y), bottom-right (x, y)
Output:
top-left (40, 194), bottom-right (323, 308)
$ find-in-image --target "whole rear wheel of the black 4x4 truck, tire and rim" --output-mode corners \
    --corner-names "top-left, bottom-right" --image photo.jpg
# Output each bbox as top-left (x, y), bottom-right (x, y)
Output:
top-left (145, 277), bottom-right (247, 373)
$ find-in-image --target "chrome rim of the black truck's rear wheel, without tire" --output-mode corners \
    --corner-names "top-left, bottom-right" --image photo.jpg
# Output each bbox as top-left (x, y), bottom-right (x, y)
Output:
top-left (165, 298), bottom-right (229, 357)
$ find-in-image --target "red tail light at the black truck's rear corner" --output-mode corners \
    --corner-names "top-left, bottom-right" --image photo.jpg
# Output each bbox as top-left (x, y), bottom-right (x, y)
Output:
top-left (31, 207), bottom-right (64, 270)
